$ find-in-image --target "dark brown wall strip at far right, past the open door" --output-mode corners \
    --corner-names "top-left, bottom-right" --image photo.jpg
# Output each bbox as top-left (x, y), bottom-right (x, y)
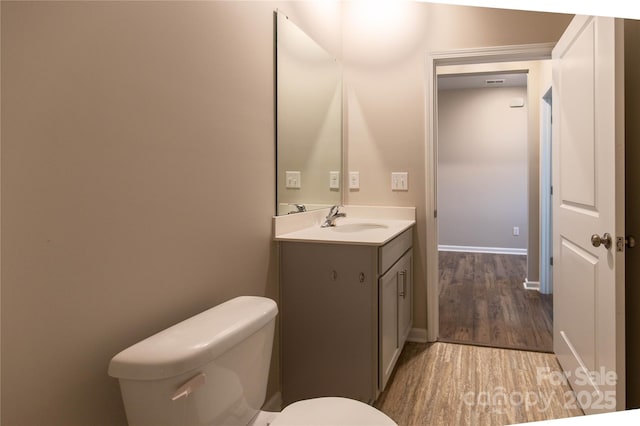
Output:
top-left (624, 20), bottom-right (640, 408)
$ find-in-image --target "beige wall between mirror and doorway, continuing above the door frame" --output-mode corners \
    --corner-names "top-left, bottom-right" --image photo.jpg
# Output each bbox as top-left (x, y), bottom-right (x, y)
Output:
top-left (342, 2), bottom-right (571, 328)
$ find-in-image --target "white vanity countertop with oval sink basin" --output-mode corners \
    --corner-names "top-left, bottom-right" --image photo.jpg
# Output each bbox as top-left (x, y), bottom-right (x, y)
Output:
top-left (274, 217), bottom-right (416, 246)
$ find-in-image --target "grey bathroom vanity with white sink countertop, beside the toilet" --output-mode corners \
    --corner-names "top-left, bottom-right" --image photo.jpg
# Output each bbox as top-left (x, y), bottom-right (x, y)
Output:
top-left (275, 207), bottom-right (415, 406)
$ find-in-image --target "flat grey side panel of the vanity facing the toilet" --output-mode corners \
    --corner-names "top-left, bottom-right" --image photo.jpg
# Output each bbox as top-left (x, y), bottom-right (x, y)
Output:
top-left (280, 243), bottom-right (378, 405)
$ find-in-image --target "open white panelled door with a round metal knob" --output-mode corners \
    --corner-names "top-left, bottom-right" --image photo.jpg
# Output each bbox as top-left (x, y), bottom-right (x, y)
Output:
top-left (552, 16), bottom-right (625, 414)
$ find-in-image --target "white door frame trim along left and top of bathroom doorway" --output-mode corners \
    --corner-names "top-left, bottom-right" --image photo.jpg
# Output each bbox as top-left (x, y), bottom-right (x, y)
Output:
top-left (425, 43), bottom-right (555, 342)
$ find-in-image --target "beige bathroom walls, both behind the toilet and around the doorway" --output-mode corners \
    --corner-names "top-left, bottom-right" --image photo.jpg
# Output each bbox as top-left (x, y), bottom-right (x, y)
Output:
top-left (1, 1), bottom-right (568, 425)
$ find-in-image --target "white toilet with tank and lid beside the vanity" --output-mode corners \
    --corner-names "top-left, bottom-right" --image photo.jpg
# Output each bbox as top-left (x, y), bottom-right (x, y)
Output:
top-left (109, 296), bottom-right (395, 426)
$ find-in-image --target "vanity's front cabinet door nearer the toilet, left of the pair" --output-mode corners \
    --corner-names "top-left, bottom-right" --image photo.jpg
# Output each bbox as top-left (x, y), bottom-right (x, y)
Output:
top-left (378, 264), bottom-right (400, 392)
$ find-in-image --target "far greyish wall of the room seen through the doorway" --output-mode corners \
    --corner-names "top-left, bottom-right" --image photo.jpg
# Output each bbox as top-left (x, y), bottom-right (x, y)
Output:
top-left (437, 87), bottom-right (528, 250)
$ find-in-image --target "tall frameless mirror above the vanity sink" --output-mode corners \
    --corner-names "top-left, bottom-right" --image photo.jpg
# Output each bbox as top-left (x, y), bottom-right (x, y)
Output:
top-left (276, 12), bottom-right (342, 215)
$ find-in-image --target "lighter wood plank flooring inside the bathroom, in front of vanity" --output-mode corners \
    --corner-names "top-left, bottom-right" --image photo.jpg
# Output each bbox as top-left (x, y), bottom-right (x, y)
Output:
top-left (374, 342), bottom-right (582, 426)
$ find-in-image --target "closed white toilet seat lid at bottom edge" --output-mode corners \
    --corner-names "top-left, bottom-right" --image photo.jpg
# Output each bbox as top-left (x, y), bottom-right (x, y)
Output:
top-left (271, 397), bottom-right (397, 426)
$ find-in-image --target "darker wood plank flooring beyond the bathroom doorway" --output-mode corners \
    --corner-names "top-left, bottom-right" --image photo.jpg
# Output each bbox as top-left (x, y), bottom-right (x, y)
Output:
top-left (439, 252), bottom-right (553, 352)
